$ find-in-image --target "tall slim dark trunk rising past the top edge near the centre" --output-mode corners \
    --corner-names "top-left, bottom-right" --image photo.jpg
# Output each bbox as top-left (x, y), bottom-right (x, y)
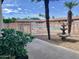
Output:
top-left (44, 0), bottom-right (51, 40)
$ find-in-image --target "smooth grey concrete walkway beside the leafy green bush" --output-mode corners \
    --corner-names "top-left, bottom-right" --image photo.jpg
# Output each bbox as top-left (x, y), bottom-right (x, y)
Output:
top-left (27, 39), bottom-right (79, 59)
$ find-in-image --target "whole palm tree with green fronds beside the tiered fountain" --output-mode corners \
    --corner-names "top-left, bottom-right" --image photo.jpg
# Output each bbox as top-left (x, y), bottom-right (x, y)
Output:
top-left (64, 1), bottom-right (78, 35)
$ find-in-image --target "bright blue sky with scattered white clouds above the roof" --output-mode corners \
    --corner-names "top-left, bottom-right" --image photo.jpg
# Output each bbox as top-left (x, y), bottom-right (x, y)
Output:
top-left (3, 0), bottom-right (79, 18)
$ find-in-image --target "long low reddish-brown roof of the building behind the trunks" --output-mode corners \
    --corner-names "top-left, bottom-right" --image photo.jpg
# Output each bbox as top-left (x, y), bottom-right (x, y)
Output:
top-left (16, 16), bottom-right (79, 23)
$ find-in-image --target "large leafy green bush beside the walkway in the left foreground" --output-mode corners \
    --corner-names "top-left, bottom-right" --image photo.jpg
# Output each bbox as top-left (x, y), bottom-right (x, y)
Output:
top-left (0, 29), bottom-right (34, 56)
